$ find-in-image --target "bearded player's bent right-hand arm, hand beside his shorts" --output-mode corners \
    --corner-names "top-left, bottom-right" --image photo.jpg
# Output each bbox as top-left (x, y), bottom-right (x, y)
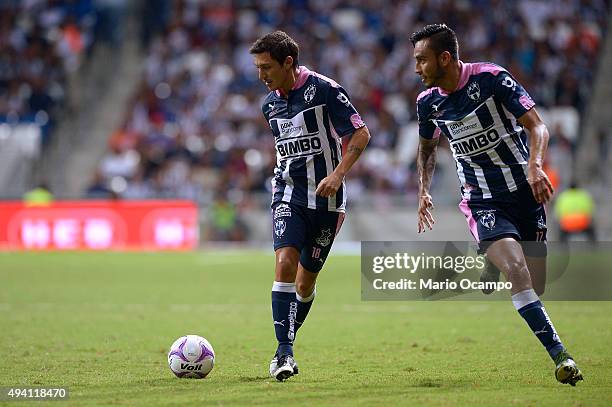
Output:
top-left (518, 108), bottom-right (555, 203)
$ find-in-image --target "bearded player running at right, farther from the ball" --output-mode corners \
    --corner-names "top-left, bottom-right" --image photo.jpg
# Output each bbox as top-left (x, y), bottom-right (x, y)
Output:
top-left (410, 24), bottom-right (582, 386)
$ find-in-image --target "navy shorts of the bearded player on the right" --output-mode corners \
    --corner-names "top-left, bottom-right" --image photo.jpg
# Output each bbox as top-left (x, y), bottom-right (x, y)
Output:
top-left (459, 184), bottom-right (547, 257)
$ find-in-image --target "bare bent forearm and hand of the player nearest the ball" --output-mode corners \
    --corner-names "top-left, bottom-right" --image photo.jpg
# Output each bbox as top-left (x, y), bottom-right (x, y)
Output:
top-left (316, 126), bottom-right (370, 198)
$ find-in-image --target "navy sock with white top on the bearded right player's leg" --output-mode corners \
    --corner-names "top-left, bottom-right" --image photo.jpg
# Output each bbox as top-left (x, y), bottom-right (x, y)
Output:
top-left (512, 288), bottom-right (565, 360)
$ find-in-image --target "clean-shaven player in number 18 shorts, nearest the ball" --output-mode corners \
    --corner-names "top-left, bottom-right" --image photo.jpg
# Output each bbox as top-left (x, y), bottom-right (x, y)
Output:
top-left (250, 31), bottom-right (370, 381)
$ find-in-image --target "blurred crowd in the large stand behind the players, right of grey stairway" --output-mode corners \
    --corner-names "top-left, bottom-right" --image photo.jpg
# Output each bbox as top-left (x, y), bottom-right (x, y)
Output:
top-left (92, 0), bottom-right (608, 214)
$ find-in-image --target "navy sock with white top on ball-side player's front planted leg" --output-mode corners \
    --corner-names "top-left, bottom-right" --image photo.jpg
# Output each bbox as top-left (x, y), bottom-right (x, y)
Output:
top-left (272, 281), bottom-right (297, 356)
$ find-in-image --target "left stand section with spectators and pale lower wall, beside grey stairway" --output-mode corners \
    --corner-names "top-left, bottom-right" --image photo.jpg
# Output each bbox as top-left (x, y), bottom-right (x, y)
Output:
top-left (0, 0), bottom-right (97, 197)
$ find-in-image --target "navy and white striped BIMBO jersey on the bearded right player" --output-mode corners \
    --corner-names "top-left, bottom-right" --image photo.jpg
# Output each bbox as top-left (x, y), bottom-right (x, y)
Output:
top-left (417, 62), bottom-right (535, 200)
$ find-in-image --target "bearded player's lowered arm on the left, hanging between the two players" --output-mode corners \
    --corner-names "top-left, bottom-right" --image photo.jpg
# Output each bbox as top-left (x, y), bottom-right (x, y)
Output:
top-left (417, 137), bottom-right (440, 233)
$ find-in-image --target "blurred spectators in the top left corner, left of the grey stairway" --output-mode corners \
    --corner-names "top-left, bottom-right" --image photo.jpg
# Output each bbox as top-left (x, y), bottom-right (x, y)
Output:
top-left (0, 0), bottom-right (96, 144)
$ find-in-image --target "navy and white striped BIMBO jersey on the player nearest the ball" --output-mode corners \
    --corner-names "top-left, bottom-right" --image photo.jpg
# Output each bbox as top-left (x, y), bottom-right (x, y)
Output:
top-left (262, 66), bottom-right (365, 212)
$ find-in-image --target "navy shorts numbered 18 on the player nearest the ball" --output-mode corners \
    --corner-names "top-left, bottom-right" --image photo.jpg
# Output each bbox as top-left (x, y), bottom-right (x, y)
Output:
top-left (272, 202), bottom-right (344, 273)
